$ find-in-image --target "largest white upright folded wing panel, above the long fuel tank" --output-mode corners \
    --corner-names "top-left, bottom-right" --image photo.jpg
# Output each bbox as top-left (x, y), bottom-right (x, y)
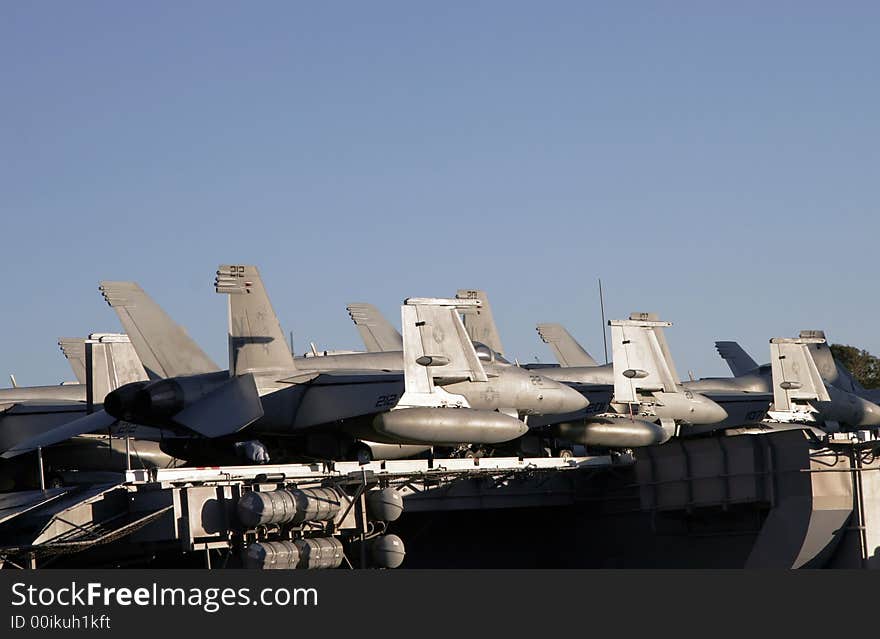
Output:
top-left (398, 298), bottom-right (488, 407)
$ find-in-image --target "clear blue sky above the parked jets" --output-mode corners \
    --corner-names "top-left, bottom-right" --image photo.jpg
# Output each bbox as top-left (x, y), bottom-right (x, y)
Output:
top-left (0, 1), bottom-right (880, 384)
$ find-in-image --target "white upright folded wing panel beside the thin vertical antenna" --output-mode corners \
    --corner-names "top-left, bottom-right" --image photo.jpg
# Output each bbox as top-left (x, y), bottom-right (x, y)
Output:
top-left (608, 313), bottom-right (678, 403)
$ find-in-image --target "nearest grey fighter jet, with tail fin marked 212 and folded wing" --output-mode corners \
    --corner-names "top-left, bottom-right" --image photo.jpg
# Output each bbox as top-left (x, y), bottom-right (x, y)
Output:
top-left (4, 265), bottom-right (587, 459)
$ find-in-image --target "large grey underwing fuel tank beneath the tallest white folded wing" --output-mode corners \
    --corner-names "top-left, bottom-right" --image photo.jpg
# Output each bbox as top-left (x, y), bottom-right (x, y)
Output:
top-left (373, 406), bottom-right (528, 446)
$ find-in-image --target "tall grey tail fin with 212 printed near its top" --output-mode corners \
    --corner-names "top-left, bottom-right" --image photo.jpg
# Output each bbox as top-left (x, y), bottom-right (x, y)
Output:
top-left (214, 264), bottom-right (296, 375)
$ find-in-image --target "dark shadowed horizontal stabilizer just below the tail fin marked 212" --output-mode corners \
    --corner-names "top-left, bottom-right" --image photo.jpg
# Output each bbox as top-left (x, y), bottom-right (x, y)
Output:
top-left (174, 374), bottom-right (263, 437)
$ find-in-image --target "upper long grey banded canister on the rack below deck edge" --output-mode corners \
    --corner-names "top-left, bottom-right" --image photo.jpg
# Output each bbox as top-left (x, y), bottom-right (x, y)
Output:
top-left (238, 488), bottom-right (341, 527)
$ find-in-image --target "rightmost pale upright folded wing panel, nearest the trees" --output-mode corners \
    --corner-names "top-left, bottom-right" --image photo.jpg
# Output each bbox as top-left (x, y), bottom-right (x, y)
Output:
top-left (770, 337), bottom-right (831, 411)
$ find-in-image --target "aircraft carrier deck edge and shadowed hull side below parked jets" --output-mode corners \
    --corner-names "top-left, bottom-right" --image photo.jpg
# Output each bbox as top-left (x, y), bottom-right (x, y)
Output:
top-left (0, 430), bottom-right (880, 568)
